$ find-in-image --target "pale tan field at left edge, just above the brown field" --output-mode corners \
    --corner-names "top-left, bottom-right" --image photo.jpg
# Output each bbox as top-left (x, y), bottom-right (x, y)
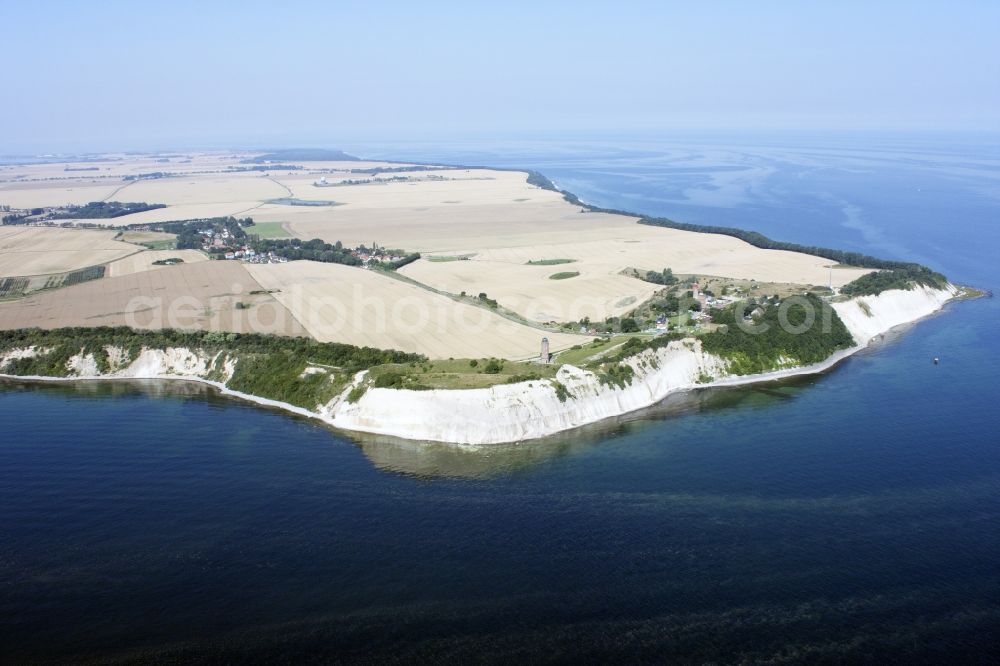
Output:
top-left (0, 226), bottom-right (139, 277)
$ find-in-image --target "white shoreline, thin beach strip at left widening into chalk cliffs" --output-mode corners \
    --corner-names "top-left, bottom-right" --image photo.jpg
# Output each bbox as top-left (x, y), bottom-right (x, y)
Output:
top-left (0, 285), bottom-right (960, 446)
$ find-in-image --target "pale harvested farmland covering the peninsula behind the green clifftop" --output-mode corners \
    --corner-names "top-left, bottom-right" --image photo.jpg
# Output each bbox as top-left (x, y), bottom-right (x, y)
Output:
top-left (0, 152), bottom-right (867, 364)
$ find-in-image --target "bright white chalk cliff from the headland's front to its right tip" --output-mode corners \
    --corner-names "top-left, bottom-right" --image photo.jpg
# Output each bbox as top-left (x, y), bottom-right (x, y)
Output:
top-left (322, 285), bottom-right (957, 444)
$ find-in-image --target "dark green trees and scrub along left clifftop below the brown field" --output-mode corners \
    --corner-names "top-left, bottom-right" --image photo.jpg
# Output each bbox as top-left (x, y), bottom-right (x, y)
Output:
top-left (0, 327), bottom-right (427, 409)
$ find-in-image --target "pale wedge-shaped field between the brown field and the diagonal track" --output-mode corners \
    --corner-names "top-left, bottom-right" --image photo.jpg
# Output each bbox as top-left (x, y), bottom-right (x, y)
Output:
top-left (248, 261), bottom-right (587, 359)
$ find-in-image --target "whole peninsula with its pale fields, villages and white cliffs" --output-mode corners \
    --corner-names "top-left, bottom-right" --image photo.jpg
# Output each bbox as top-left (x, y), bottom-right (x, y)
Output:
top-left (0, 151), bottom-right (967, 445)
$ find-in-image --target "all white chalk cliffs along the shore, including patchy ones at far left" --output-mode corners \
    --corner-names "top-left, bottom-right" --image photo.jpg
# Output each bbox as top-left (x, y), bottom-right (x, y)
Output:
top-left (0, 285), bottom-right (958, 444)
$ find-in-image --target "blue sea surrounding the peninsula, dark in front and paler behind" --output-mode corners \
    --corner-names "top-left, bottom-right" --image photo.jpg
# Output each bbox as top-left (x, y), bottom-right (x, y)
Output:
top-left (0, 136), bottom-right (1000, 664)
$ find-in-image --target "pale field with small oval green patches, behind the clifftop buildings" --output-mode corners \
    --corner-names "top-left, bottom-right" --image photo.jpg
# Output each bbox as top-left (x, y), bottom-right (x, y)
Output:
top-left (400, 223), bottom-right (868, 321)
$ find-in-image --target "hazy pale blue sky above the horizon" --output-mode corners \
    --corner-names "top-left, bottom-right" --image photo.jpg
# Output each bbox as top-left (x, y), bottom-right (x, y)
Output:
top-left (0, 0), bottom-right (1000, 153)
